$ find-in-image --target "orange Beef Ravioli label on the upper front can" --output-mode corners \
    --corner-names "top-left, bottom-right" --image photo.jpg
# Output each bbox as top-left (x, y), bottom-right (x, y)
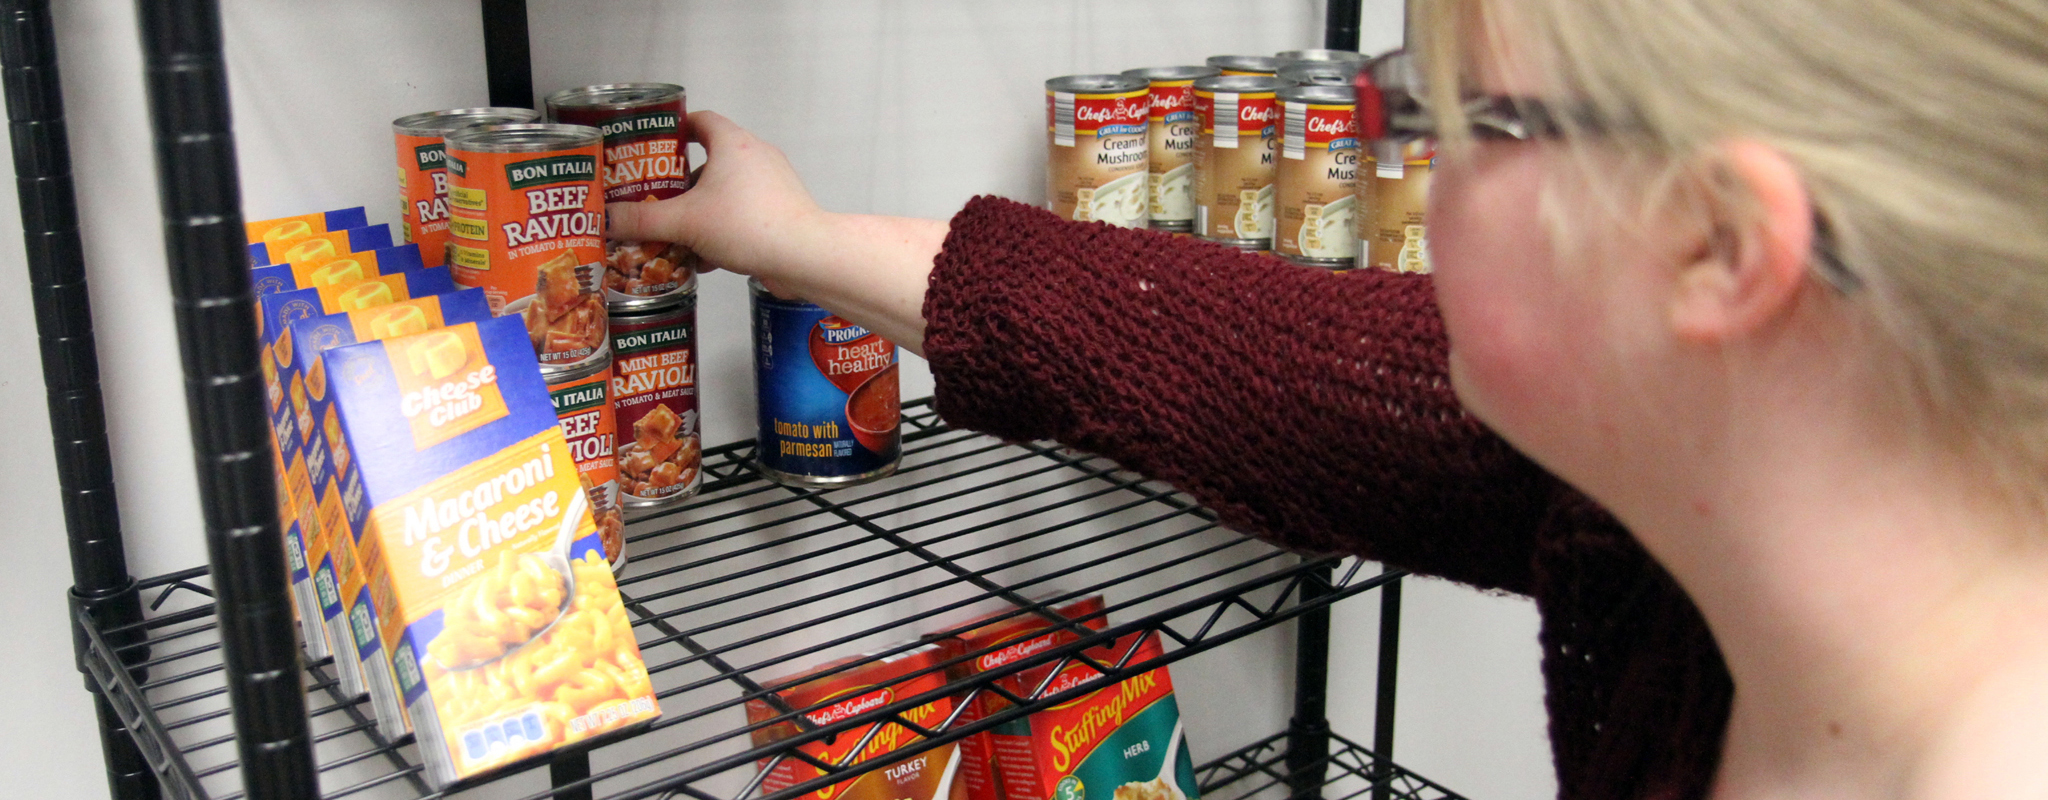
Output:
top-left (446, 143), bottom-right (606, 366)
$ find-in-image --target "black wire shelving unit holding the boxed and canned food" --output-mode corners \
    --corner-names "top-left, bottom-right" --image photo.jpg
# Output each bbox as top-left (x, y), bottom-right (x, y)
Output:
top-left (0, 0), bottom-right (1458, 800)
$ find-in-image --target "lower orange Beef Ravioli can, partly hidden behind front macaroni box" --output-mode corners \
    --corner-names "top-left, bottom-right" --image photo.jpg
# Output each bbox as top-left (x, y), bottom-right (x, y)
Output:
top-left (547, 353), bottom-right (627, 573)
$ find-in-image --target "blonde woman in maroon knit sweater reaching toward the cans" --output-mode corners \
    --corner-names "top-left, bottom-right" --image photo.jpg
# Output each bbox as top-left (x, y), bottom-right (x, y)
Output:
top-left (610, 0), bottom-right (2048, 798)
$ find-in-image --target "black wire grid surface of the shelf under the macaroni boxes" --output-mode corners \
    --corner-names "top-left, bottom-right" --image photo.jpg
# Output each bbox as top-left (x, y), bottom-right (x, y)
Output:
top-left (96, 401), bottom-right (1384, 800)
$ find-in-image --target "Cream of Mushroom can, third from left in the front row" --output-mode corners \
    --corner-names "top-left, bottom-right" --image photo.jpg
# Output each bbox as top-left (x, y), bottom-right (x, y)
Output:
top-left (1194, 76), bottom-right (1280, 250)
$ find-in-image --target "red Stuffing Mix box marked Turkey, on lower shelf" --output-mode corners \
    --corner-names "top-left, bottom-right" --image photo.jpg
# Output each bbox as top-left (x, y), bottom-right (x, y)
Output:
top-left (748, 642), bottom-right (967, 800)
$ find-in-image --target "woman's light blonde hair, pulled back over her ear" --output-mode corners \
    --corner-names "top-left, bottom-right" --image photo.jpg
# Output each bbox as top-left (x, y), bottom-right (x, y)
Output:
top-left (1415, 0), bottom-right (2048, 482)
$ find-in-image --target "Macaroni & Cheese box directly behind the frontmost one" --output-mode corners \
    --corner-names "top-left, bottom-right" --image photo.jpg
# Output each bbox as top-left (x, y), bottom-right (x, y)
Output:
top-left (279, 288), bottom-right (492, 737)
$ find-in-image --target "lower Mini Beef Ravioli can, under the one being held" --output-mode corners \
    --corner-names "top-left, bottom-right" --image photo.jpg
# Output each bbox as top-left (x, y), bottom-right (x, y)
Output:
top-left (612, 286), bottom-right (705, 509)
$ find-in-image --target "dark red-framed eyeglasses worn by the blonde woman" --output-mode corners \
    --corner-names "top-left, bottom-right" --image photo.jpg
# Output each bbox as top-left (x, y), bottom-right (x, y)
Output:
top-left (1354, 57), bottom-right (1864, 295)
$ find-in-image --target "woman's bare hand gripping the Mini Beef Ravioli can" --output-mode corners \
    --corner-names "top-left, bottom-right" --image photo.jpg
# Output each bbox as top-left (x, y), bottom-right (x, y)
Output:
top-left (604, 110), bottom-right (829, 282)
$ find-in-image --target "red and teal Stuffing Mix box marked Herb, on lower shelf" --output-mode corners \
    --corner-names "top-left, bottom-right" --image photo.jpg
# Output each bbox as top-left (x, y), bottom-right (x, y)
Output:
top-left (991, 632), bottom-right (1200, 800)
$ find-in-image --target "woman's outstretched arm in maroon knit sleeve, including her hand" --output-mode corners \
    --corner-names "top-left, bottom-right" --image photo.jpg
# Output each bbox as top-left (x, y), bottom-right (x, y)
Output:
top-left (610, 113), bottom-right (1561, 591)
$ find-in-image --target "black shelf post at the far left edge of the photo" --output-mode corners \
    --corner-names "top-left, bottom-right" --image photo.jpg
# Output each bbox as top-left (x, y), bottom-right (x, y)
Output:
top-left (0, 0), bottom-right (158, 798)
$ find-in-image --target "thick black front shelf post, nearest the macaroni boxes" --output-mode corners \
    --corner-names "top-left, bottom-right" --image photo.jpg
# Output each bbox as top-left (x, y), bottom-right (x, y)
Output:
top-left (135, 0), bottom-right (319, 800)
